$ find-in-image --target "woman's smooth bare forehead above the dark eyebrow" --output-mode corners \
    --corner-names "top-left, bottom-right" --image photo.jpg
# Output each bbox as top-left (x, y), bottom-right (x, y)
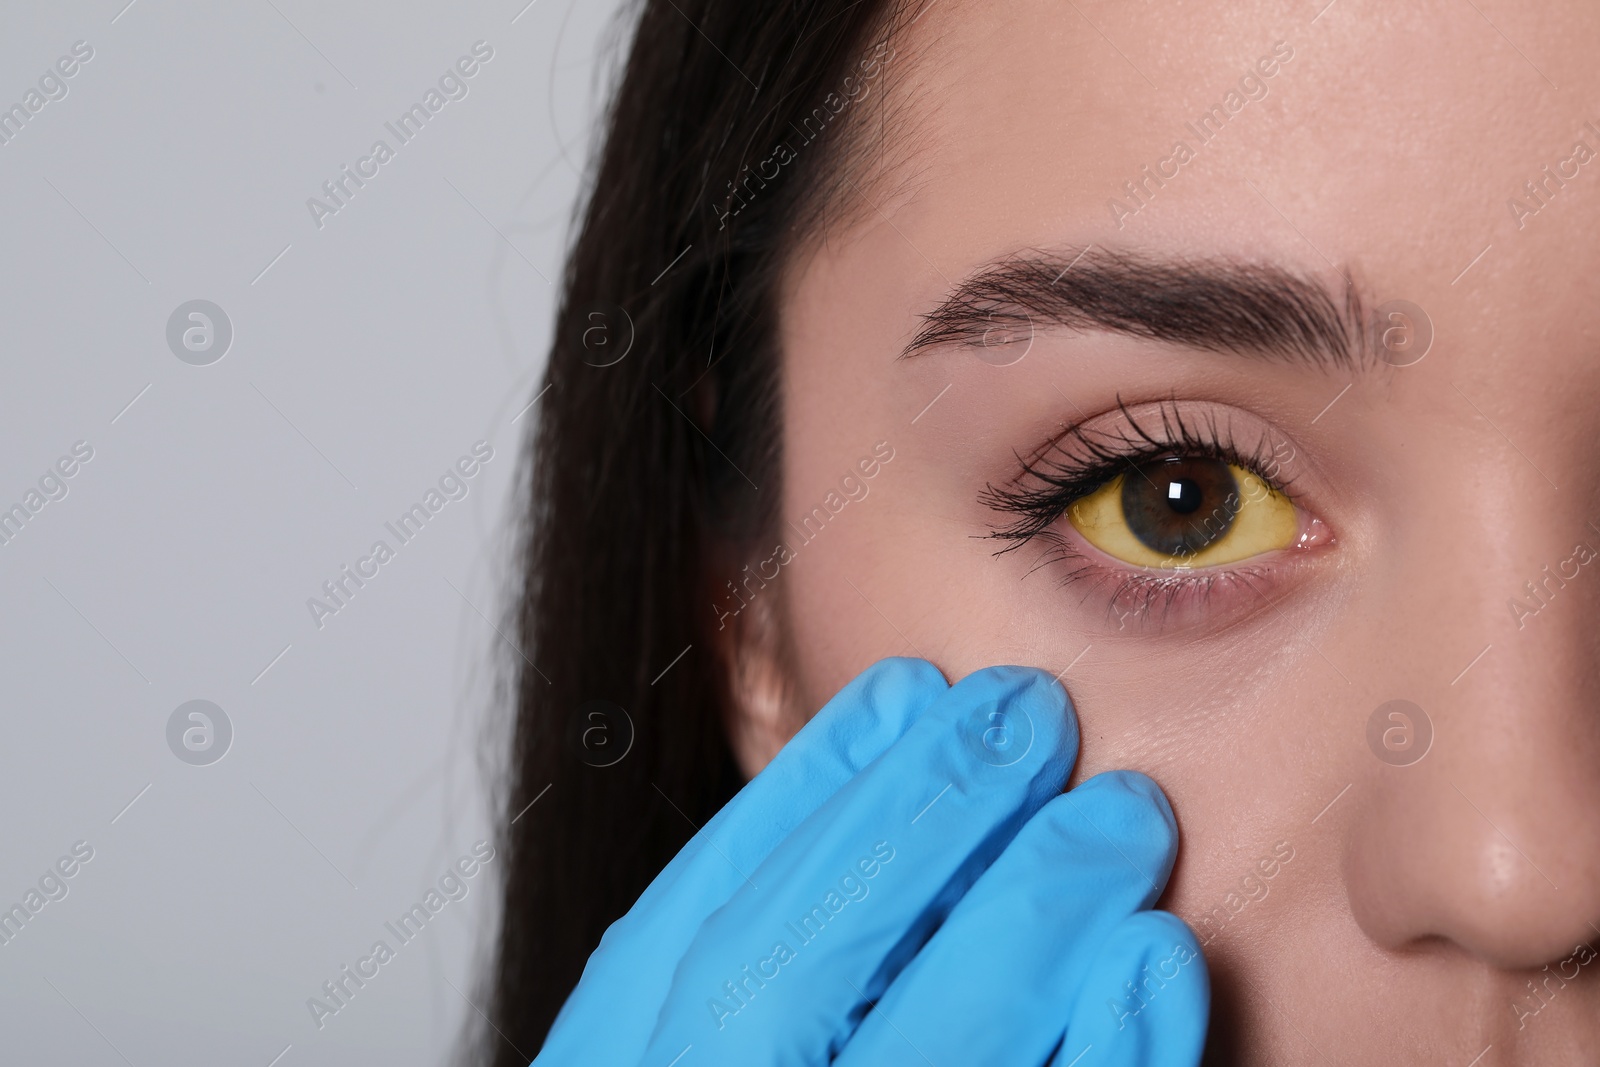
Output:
top-left (792, 0), bottom-right (1600, 350)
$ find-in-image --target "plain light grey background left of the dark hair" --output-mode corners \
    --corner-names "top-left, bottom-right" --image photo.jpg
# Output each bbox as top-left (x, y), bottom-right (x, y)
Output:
top-left (0, 0), bottom-right (618, 1067)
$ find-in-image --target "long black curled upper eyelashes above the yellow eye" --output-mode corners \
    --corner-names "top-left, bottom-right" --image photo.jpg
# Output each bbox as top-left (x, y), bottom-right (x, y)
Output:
top-left (978, 395), bottom-right (1294, 555)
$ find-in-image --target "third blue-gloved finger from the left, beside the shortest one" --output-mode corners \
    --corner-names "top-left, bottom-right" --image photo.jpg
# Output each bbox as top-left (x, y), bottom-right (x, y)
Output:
top-left (834, 771), bottom-right (1178, 1067)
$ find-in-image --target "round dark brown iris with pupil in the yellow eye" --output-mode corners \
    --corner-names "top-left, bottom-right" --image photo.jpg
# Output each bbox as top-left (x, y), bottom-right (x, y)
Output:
top-left (1122, 456), bottom-right (1240, 557)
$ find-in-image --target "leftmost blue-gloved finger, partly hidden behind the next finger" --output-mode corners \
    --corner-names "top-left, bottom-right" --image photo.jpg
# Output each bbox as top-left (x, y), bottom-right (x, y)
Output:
top-left (539, 657), bottom-right (950, 1064)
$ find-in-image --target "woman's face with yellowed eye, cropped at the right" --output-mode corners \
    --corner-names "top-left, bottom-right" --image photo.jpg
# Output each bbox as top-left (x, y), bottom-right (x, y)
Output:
top-left (741, 0), bottom-right (1600, 1067)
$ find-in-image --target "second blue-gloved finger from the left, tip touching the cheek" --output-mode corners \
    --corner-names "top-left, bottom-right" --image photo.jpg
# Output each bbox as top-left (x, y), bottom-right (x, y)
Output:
top-left (646, 667), bottom-right (1077, 1067)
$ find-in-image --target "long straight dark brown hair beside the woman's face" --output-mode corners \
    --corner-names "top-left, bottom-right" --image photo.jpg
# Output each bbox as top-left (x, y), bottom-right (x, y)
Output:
top-left (467, 0), bottom-right (899, 1067)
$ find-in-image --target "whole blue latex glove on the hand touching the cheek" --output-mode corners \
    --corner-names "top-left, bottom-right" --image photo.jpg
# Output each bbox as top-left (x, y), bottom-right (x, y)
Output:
top-left (534, 659), bottom-right (1210, 1067)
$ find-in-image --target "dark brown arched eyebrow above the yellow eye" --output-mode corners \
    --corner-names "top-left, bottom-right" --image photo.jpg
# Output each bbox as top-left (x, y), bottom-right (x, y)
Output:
top-left (899, 245), bottom-right (1371, 370)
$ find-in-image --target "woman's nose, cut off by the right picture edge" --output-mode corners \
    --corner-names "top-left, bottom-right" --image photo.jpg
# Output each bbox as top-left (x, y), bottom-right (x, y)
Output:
top-left (1344, 498), bottom-right (1600, 969)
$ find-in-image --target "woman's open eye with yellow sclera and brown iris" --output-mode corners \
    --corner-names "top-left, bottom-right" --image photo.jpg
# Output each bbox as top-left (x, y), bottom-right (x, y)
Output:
top-left (1067, 456), bottom-right (1301, 571)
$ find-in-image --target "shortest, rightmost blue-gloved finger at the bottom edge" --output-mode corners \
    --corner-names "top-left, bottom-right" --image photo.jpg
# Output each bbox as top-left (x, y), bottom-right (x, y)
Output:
top-left (1051, 912), bottom-right (1211, 1067)
